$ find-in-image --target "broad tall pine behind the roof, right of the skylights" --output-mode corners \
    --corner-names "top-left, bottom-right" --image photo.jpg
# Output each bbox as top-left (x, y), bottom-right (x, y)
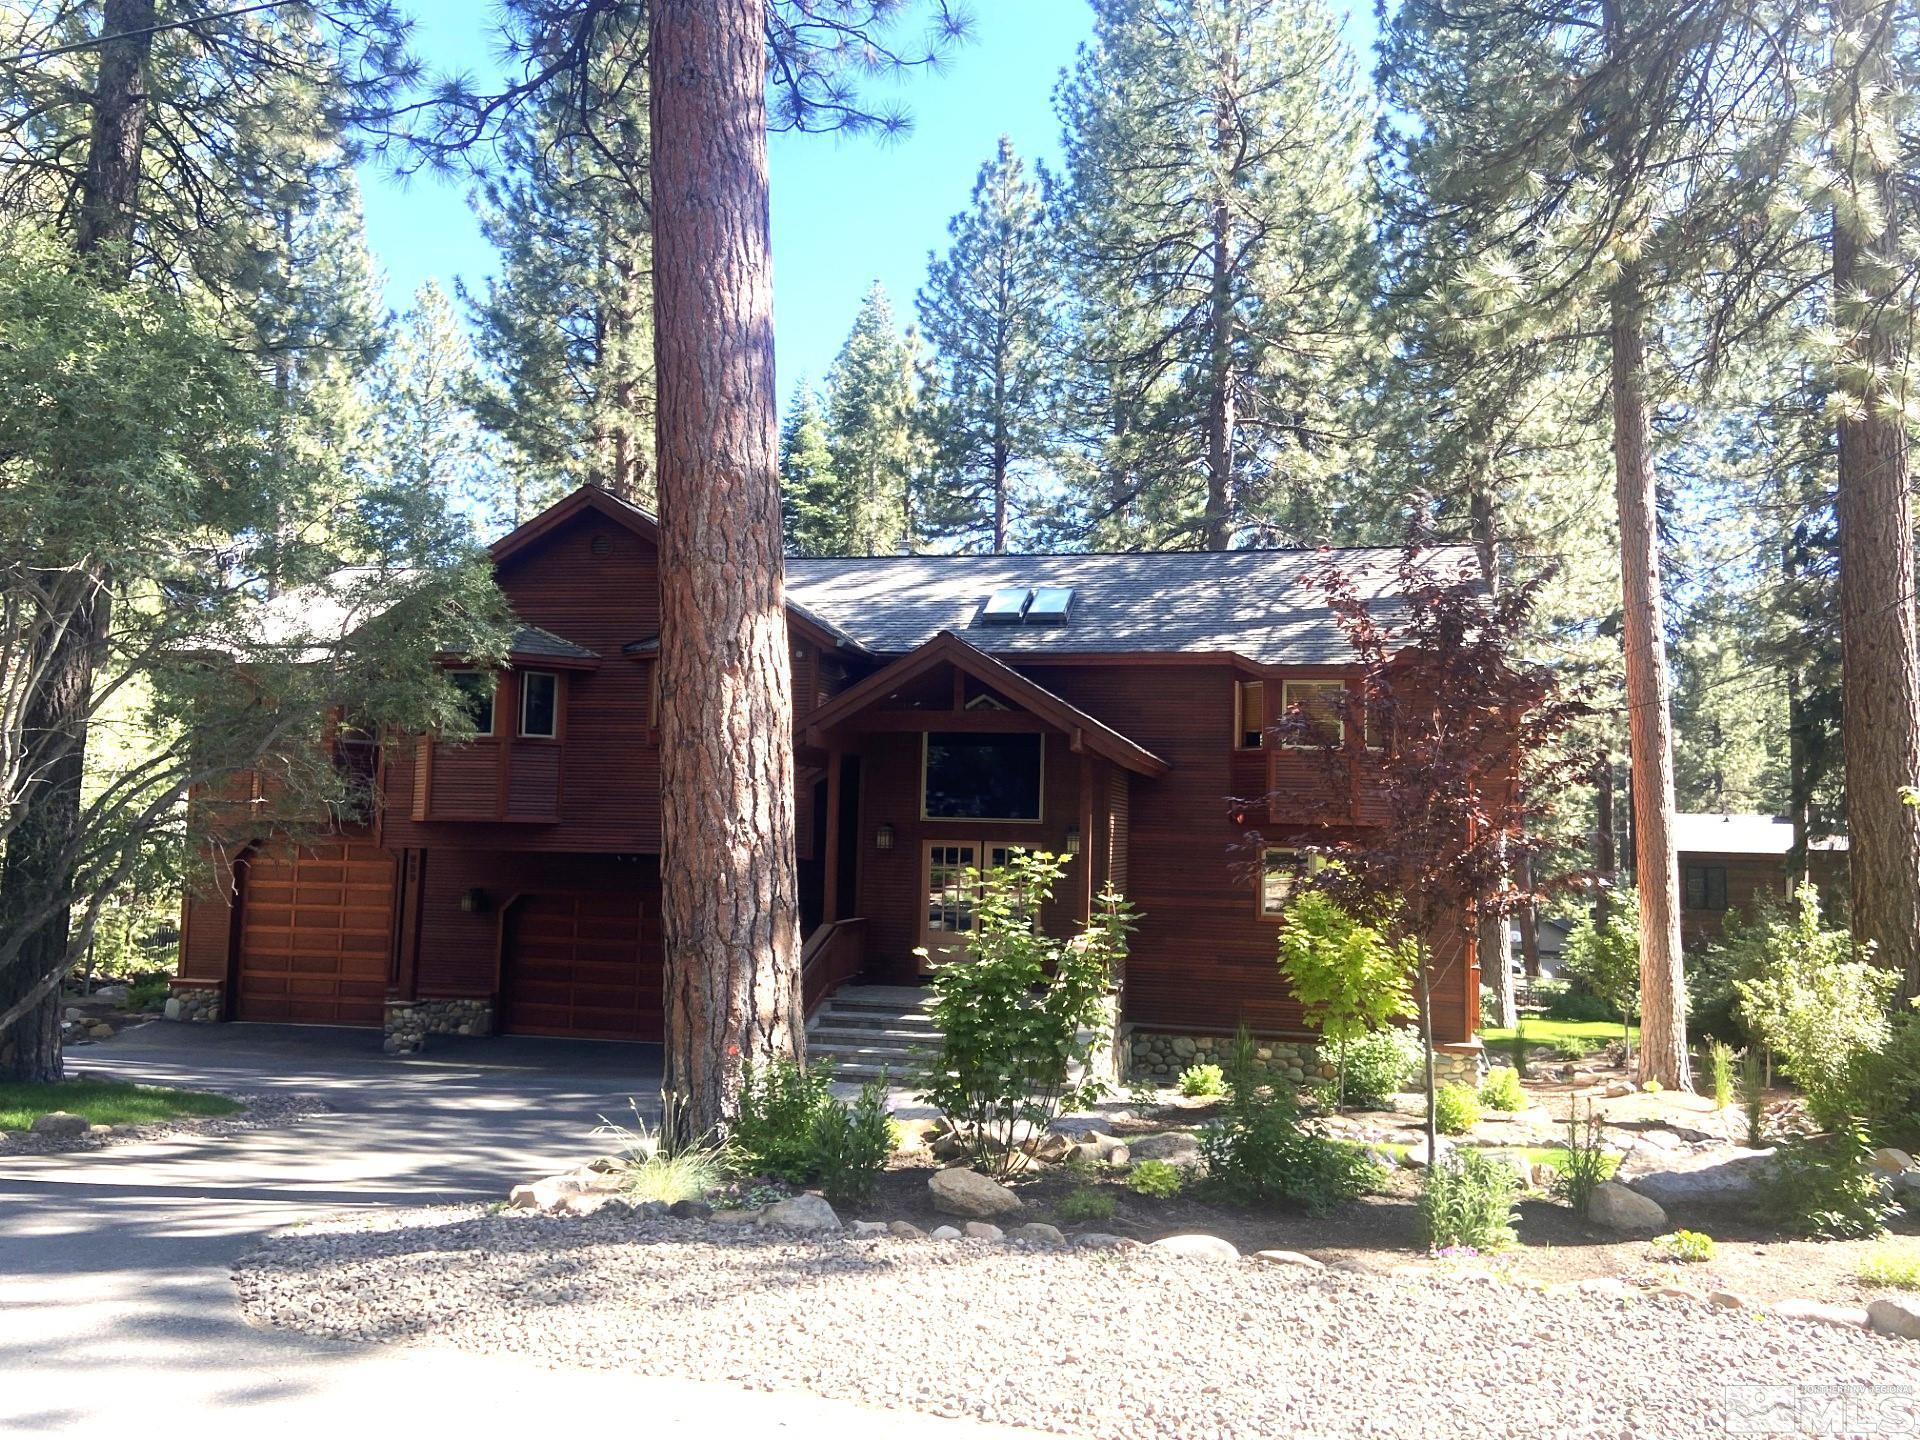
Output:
top-left (1058, 0), bottom-right (1369, 549)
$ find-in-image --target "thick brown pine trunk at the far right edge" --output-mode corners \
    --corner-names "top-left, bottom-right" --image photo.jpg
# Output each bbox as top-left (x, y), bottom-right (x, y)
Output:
top-left (1834, 0), bottom-right (1920, 995)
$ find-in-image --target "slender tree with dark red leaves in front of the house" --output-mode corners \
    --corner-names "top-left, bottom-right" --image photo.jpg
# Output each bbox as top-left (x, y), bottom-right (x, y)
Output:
top-left (1251, 549), bottom-right (1592, 1154)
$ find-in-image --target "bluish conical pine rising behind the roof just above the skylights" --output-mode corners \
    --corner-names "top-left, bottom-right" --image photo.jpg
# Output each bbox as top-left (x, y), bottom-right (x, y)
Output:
top-left (920, 136), bottom-right (1060, 555)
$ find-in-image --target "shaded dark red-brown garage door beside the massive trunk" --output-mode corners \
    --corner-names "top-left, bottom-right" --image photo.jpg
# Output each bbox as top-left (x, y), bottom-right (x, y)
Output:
top-left (501, 893), bottom-right (660, 1041)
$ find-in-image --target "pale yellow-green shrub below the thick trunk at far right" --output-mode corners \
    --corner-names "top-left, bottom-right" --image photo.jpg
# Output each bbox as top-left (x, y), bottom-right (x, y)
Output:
top-left (1734, 885), bottom-right (1899, 1129)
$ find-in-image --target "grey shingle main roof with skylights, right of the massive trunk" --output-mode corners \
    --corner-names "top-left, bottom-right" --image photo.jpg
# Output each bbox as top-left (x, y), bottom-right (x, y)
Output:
top-left (787, 545), bottom-right (1471, 664)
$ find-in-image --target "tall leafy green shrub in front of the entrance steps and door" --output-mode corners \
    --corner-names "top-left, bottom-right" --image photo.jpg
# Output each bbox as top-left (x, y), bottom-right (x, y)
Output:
top-left (920, 849), bottom-right (1133, 1179)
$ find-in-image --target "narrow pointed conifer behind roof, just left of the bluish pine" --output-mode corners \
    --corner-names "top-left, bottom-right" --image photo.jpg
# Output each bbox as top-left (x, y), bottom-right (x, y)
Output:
top-left (822, 282), bottom-right (925, 555)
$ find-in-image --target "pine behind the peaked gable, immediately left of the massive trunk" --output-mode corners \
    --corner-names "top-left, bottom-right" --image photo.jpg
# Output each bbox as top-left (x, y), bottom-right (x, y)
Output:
top-left (463, 6), bottom-right (653, 524)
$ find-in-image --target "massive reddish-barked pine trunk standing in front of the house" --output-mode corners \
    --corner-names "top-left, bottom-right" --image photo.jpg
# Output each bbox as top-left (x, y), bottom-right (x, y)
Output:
top-left (651, 0), bottom-right (804, 1135)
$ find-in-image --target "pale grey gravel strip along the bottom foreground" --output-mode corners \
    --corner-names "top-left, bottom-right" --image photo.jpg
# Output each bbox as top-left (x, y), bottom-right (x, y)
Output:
top-left (234, 1210), bottom-right (1920, 1440)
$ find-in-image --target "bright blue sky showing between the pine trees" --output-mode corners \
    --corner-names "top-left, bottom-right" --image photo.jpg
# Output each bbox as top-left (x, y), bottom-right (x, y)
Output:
top-left (363, 0), bottom-right (1373, 407)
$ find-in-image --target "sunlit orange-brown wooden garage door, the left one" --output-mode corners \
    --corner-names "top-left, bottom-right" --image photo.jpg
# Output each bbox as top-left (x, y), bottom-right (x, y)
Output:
top-left (234, 841), bottom-right (394, 1025)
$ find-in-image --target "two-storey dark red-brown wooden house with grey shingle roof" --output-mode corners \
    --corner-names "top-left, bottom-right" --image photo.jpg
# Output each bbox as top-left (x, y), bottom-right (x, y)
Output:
top-left (175, 488), bottom-right (1480, 1056)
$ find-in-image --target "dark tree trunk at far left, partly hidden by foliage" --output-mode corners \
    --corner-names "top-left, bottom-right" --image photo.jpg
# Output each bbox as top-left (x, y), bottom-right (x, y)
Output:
top-left (0, 0), bottom-right (156, 1081)
